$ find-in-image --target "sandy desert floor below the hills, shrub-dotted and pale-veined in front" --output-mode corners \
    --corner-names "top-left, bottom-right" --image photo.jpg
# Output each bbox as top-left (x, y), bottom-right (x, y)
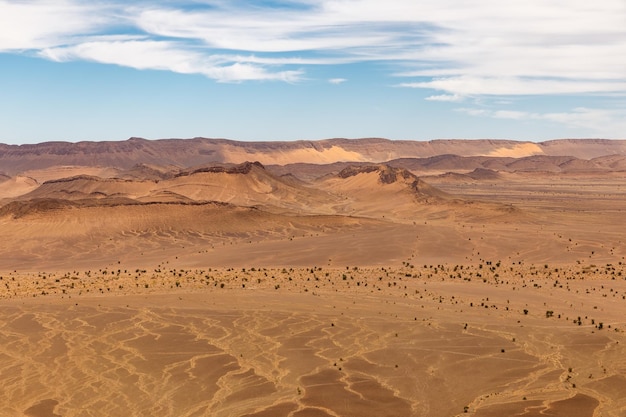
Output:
top-left (0, 174), bottom-right (626, 417)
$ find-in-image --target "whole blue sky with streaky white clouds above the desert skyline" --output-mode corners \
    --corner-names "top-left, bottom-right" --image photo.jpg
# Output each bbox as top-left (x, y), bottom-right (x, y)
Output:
top-left (0, 0), bottom-right (626, 144)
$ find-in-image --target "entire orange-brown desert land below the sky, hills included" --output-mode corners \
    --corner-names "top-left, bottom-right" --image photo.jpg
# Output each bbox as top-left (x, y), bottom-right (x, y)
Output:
top-left (0, 139), bottom-right (626, 417)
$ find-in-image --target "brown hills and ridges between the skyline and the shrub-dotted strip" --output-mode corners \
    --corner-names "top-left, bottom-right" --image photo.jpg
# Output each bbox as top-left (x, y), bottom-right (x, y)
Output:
top-left (0, 138), bottom-right (626, 270)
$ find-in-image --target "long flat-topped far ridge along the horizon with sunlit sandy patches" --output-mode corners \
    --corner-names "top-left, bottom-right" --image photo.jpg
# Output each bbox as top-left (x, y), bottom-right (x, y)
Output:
top-left (0, 138), bottom-right (626, 176)
